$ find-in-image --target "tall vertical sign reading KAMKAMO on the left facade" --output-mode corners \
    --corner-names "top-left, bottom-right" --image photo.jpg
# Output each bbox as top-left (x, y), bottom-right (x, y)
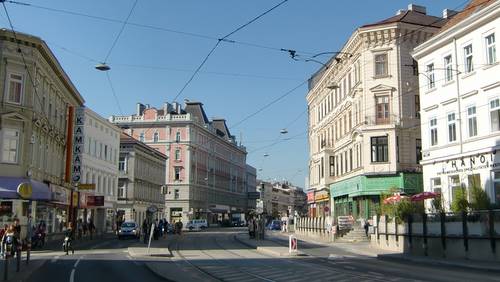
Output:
top-left (71, 107), bottom-right (85, 184)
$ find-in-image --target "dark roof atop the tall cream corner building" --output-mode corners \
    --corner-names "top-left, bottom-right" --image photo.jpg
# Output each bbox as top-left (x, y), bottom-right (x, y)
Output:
top-left (361, 10), bottom-right (446, 28)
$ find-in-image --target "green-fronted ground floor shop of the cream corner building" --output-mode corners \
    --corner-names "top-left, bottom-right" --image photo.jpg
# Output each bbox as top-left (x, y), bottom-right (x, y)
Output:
top-left (330, 172), bottom-right (423, 219)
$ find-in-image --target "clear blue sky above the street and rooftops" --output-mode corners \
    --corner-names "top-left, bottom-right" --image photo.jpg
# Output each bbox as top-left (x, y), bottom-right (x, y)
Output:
top-left (0, 0), bottom-right (466, 186)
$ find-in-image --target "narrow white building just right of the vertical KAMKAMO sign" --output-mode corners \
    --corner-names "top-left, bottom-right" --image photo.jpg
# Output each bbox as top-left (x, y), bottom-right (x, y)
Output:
top-left (79, 108), bottom-right (121, 231)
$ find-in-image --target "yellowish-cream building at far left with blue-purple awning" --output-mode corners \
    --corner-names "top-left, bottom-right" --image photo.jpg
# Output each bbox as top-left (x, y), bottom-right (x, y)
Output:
top-left (0, 29), bottom-right (84, 232)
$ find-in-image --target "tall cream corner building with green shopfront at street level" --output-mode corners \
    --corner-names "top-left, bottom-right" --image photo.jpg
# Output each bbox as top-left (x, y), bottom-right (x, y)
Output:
top-left (307, 4), bottom-right (446, 218)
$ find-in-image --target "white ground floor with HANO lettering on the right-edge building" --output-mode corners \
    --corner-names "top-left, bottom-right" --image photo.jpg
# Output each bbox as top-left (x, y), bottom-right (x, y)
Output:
top-left (423, 150), bottom-right (500, 212)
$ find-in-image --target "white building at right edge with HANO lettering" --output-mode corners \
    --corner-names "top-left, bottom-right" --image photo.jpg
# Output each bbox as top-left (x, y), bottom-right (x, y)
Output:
top-left (413, 0), bottom-right (500, 208)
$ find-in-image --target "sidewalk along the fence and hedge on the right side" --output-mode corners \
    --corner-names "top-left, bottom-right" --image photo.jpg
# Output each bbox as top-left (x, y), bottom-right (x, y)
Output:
top-left (267, 232), bottom-right (500, 272)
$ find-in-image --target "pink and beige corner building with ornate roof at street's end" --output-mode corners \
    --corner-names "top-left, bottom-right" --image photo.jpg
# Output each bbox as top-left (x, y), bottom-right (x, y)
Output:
top-left (109, 102), bottom-right (247, 223)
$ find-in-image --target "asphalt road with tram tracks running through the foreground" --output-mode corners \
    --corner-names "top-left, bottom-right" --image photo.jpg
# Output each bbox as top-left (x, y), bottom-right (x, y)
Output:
top-left (24, 229), bottom-right (500, 282)
